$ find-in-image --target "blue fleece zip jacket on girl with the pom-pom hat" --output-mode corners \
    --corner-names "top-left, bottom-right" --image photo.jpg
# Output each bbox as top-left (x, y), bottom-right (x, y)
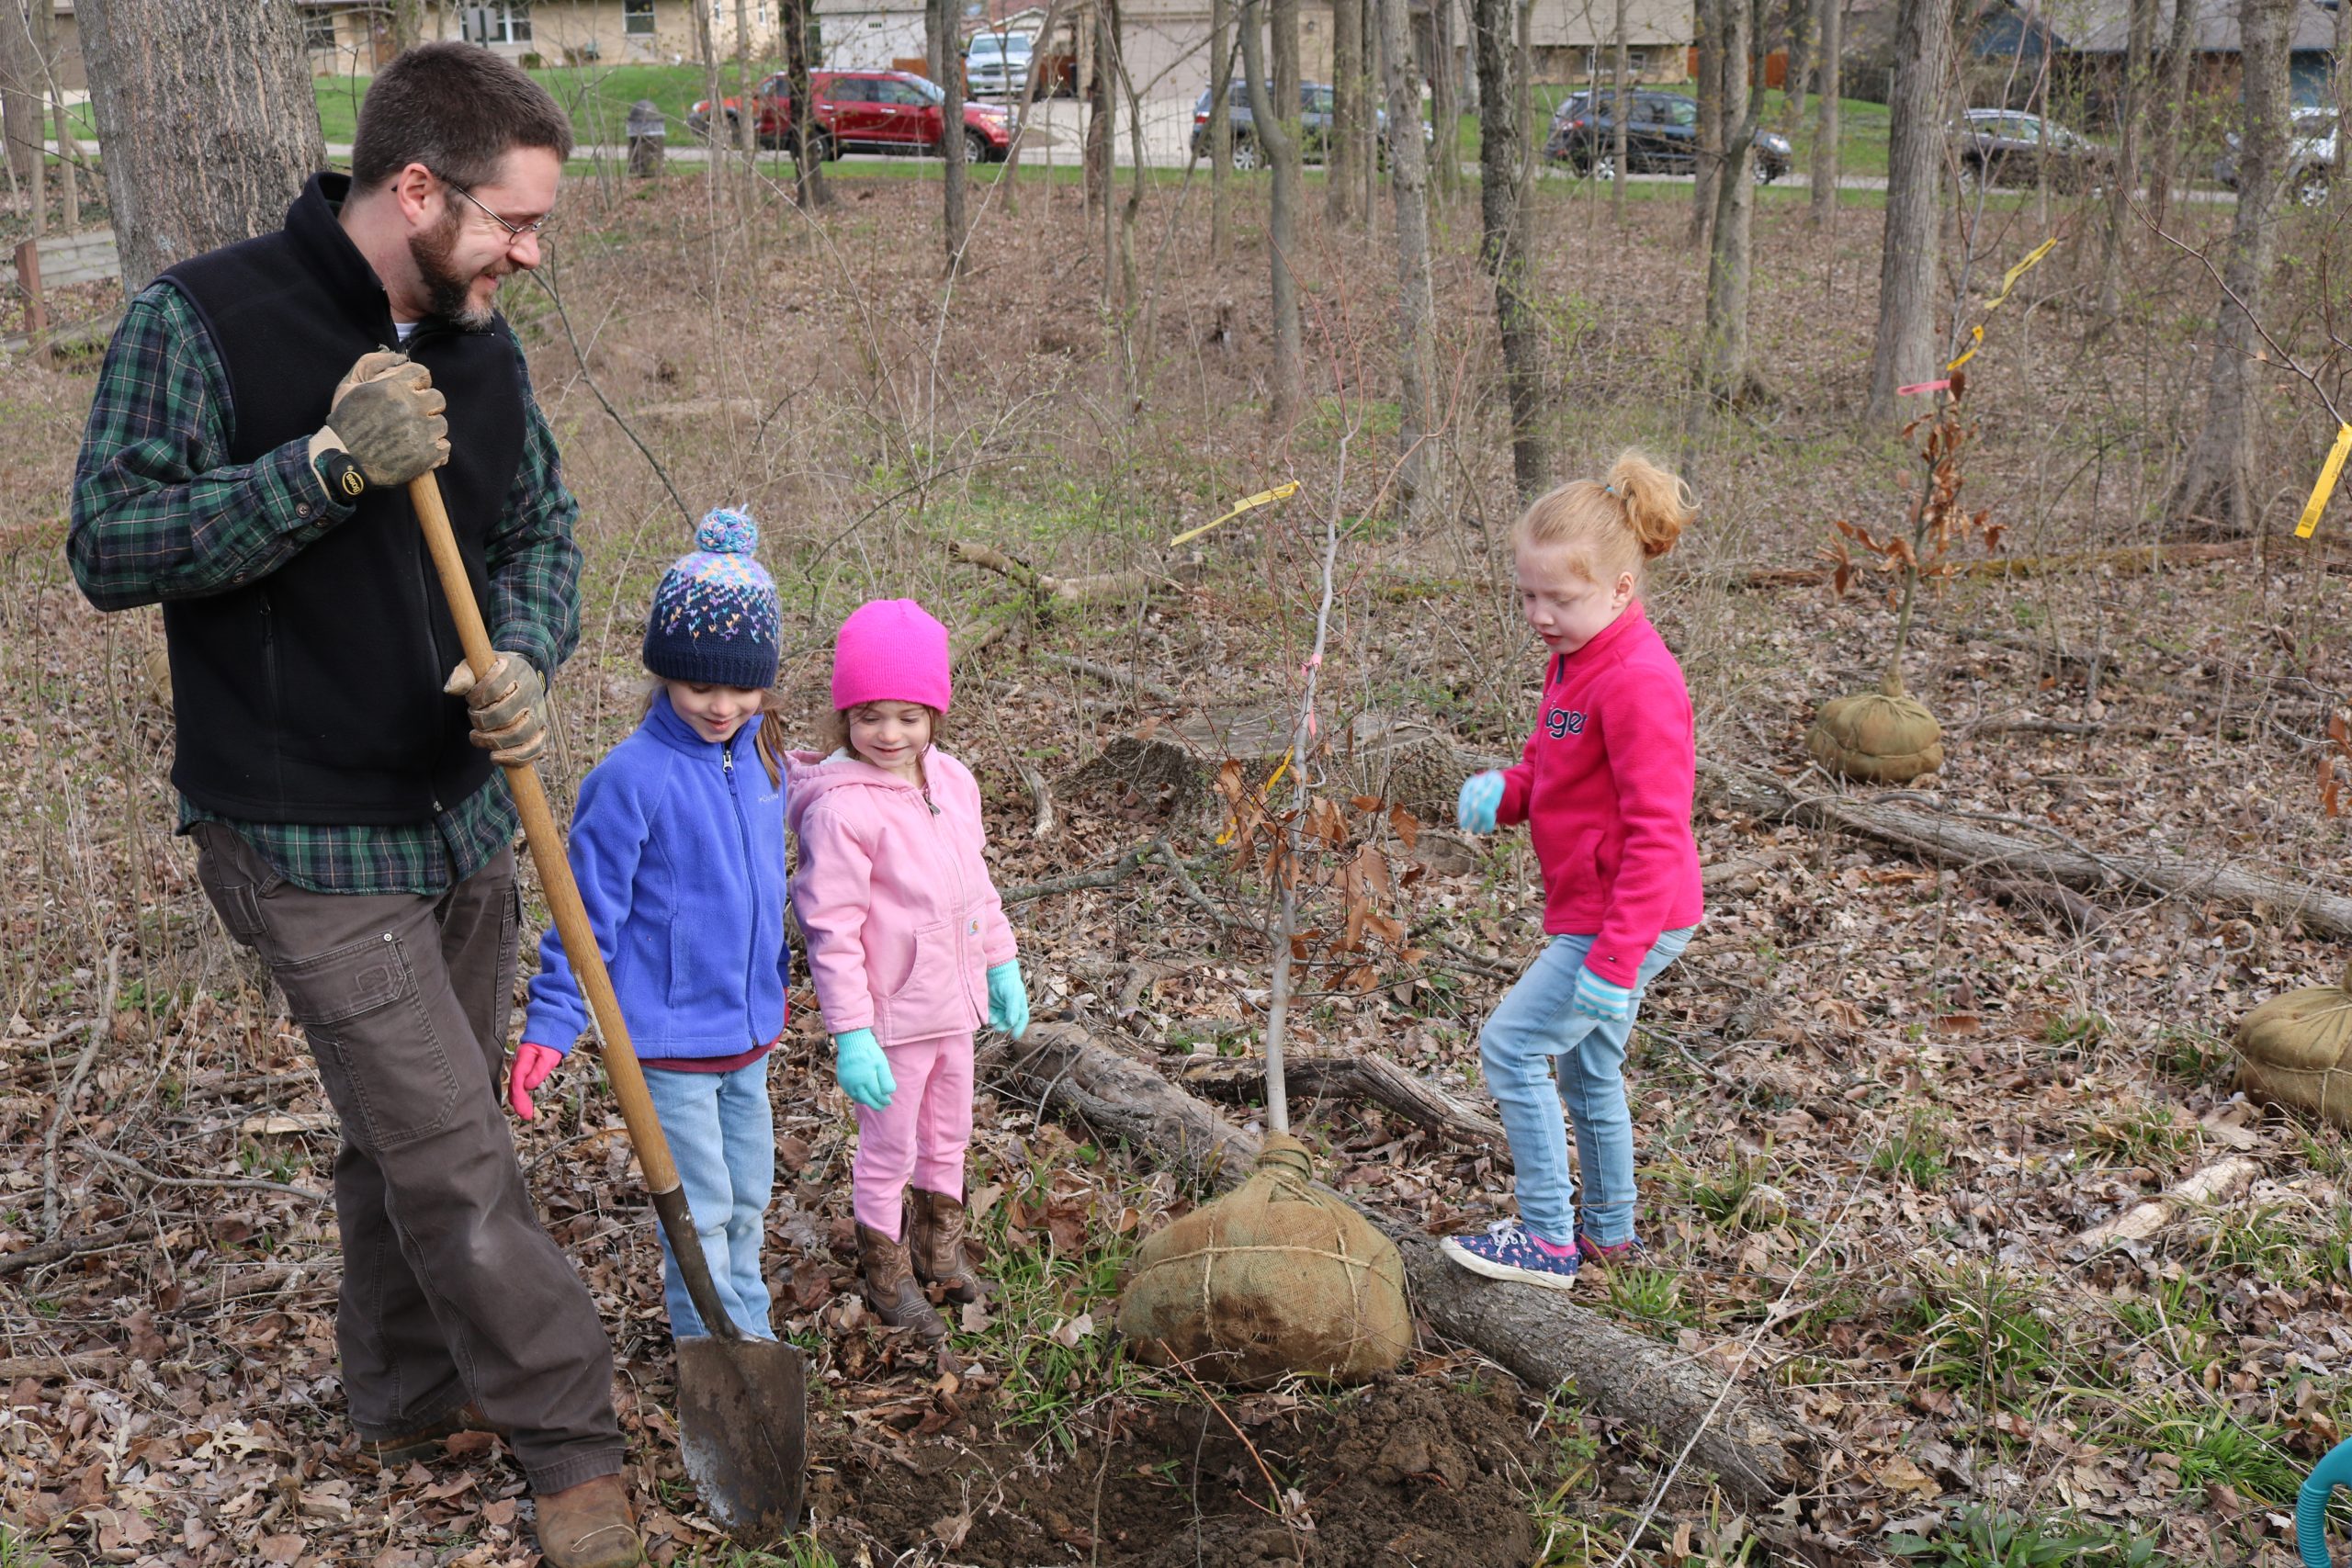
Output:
top-left (522, 691), bottom-right (793, 1060)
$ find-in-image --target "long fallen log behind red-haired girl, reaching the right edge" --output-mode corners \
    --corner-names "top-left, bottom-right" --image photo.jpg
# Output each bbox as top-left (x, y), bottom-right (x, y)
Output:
top-left (1698, 757), bottom-right (2352, 936)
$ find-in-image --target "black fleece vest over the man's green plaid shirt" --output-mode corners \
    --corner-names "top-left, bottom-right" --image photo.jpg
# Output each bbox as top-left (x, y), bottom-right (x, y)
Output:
top-left (163, 174), bottom-right (525, 828)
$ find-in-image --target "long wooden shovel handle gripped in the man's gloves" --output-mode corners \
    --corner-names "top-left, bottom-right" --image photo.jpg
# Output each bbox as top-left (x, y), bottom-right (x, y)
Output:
top-left (409, 470), bottom-right (741, 1340)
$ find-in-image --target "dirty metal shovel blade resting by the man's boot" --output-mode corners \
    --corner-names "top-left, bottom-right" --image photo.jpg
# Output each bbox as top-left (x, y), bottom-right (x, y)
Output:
top-left (677, 1337), bottom-right (809, 1547)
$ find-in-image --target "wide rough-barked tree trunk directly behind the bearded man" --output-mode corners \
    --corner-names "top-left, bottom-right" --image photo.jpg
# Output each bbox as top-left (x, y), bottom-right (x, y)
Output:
top-left (75, 0), bottom-right (327, 296)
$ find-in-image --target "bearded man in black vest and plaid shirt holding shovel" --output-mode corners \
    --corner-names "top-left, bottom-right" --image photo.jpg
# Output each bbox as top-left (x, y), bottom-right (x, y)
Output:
top-left (68, 45), bottom-right (639, 1568)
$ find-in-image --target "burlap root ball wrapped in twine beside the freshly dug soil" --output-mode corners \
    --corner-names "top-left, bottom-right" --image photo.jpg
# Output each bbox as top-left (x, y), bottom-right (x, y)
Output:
top-left (1120, 1134), bottom-right (1414, 1384)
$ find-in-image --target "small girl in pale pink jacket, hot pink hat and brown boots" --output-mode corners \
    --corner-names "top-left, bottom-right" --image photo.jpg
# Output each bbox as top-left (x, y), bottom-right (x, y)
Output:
top-left (786, 600), bottom-right (1028, 1345)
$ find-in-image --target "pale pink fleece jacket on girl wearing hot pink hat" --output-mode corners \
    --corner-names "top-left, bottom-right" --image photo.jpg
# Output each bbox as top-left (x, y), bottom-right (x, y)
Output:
top-left (786, 748), bottom-right (1013, 1046)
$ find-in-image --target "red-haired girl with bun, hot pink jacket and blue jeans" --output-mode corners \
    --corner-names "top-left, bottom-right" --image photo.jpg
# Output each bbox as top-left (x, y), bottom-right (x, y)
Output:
top-left (1442, 451), bottom-right (1701, 1291)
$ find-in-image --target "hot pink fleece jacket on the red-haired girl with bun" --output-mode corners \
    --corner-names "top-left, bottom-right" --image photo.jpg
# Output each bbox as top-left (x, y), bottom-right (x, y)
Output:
top-left (1494, 600), bottom-right (1705, 987)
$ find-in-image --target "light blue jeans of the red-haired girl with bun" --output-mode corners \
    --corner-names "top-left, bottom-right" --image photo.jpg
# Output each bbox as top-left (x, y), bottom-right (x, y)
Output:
top-left (1477, 931), bottom-right (1691, 1246)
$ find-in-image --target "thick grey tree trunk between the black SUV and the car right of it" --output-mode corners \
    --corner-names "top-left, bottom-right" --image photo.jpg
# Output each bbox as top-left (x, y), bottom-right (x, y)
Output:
top-left (1863, 0), bottom-right (1952, 423)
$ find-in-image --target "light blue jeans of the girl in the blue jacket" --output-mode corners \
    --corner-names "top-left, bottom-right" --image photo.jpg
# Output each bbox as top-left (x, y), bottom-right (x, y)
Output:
top-left (644, 1055), bottom-right (776, 1340)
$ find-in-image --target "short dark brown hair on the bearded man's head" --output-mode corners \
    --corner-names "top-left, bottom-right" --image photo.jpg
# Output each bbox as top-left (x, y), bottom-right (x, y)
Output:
top-left (350, 42), bottom-right (571, 190)
